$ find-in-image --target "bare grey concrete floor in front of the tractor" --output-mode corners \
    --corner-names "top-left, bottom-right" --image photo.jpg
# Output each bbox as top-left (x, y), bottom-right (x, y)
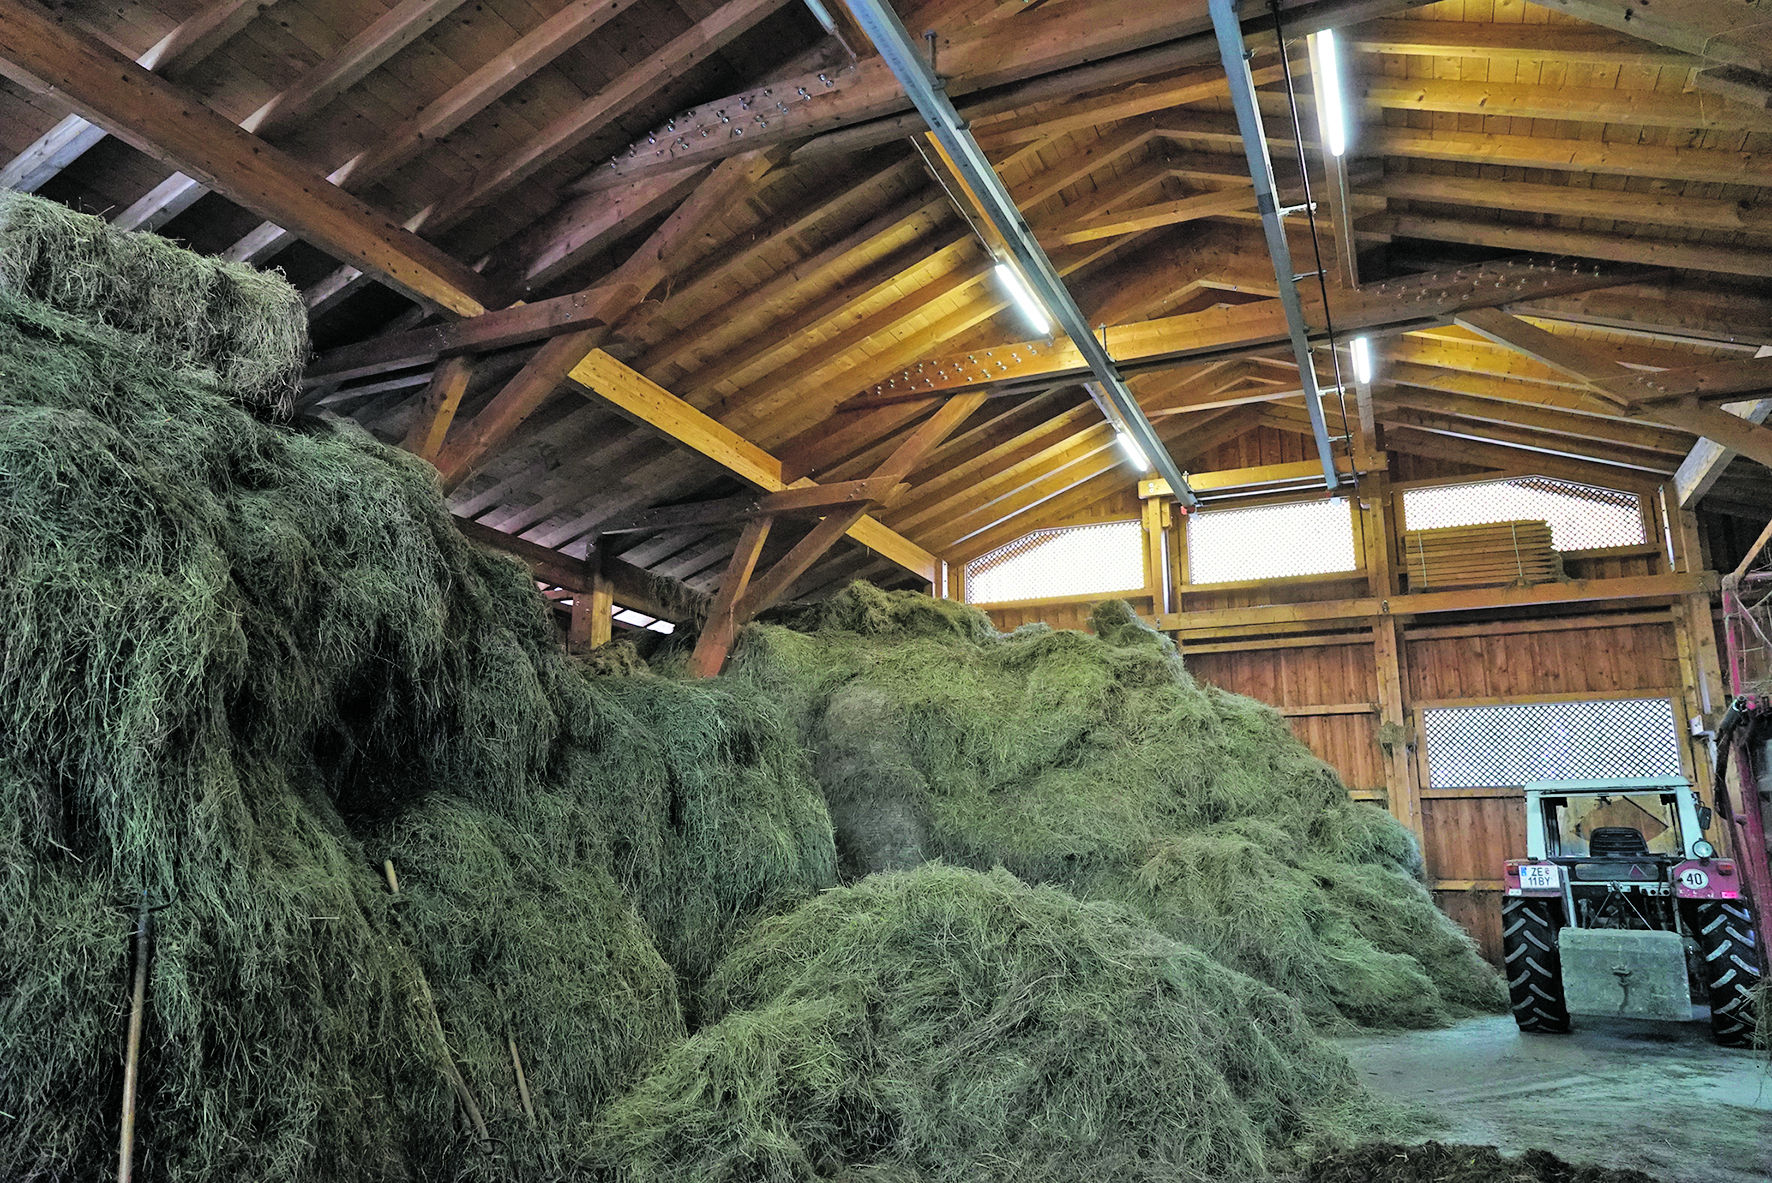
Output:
top-left (1340, 1017), bottom-right (1772, 1183)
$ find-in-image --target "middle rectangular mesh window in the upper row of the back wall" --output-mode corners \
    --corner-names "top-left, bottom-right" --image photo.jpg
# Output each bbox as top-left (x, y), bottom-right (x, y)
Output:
top-left (1187, 498), bottom-right (1359, 583)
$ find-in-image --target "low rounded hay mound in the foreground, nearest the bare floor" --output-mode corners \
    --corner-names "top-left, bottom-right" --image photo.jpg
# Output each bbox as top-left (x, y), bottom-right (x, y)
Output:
top-left (599, 866), bottom-right (1396, 1183)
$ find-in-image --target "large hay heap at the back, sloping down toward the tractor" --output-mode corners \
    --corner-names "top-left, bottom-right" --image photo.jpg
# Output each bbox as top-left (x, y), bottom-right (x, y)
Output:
top-left (735, 584), bottom-right (1504, 1027)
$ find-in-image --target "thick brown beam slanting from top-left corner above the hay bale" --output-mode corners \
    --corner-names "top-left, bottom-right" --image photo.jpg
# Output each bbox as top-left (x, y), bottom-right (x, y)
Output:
top-left (0, 0), bottom-right (486, 315)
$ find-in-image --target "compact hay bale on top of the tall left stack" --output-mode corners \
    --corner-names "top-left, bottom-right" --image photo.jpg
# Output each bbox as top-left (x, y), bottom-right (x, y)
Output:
top-left (0, 191), bottom-right (308, 414)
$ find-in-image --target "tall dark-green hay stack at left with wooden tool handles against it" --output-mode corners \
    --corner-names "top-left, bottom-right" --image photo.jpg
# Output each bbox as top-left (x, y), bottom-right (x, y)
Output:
top-left (0, 198), bottom-right (835, 1181)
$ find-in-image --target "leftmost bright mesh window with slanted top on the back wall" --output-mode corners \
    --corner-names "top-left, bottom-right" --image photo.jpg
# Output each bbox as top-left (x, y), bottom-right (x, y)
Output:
top-left (966, 522), bottom-right (1145, 604)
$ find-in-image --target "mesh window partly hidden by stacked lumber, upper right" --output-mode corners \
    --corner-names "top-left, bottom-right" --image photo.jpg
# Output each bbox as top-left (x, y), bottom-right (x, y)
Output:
top-left (1403, 476), bottom-right (1648, 551)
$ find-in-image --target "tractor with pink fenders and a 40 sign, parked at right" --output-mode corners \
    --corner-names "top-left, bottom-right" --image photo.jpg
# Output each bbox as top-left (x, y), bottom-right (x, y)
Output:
top-left (1501, 777), bottom-right (1763, 1047)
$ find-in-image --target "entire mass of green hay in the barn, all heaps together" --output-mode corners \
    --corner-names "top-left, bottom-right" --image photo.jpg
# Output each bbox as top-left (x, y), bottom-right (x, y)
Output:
top-left (0, 197), bottom-right (1485, 1183)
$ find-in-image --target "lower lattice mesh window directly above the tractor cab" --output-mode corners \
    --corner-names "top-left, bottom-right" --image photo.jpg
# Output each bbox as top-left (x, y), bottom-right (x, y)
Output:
top-left (1421, 698), bottom-right (1682, 788)
